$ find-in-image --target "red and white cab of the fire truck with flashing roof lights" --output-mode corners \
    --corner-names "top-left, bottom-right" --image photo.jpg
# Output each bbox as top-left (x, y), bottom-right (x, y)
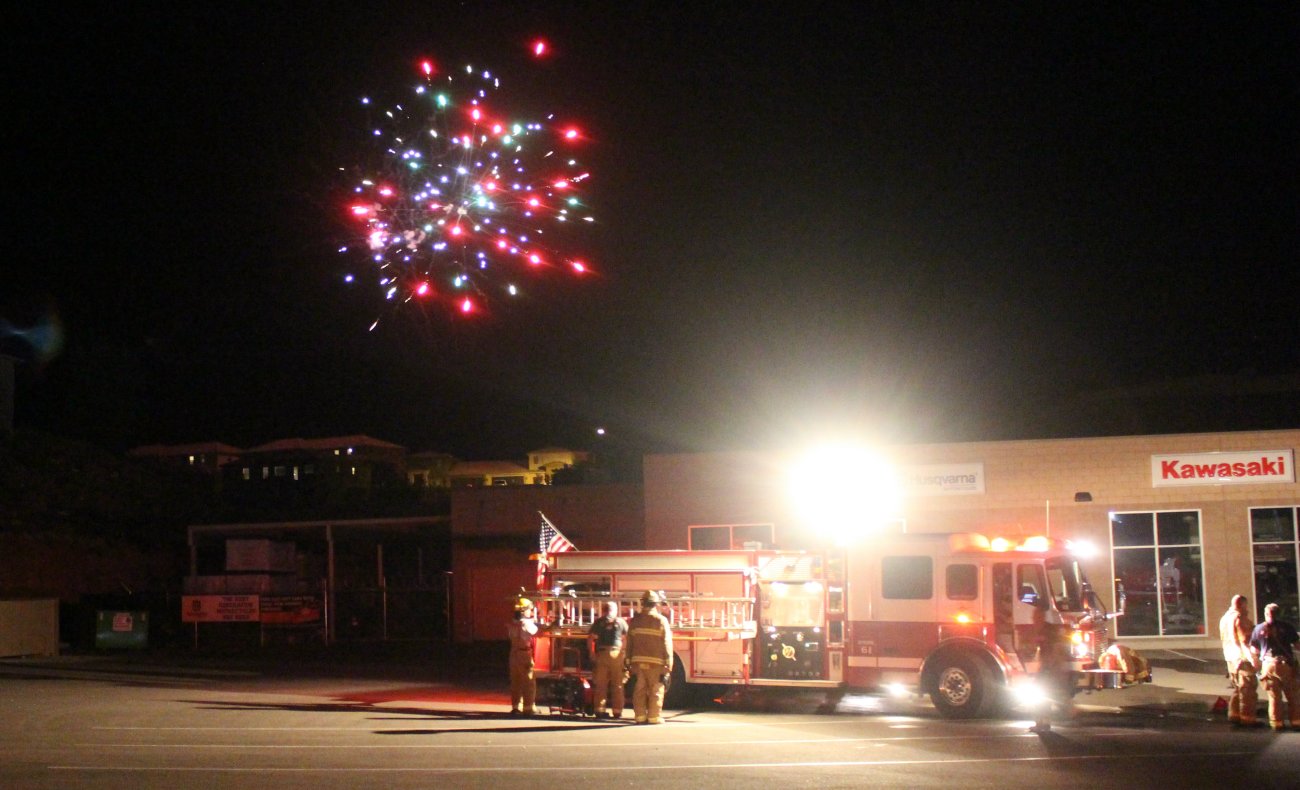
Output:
top-left (845, 533), bottom-right (1123, 717)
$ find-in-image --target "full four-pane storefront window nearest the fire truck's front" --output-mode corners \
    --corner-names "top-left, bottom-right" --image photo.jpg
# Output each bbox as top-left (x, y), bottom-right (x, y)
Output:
top-left (1110, 511), bottom-right (1205, 637)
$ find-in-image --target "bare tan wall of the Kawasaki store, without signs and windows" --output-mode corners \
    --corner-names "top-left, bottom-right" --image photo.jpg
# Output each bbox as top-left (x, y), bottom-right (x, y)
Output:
top-left (645, 430), bottom-right (1300, 648)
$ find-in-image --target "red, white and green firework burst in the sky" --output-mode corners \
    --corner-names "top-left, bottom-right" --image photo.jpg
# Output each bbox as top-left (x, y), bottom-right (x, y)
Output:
top-left (339, 52), bottom-right (594, 329)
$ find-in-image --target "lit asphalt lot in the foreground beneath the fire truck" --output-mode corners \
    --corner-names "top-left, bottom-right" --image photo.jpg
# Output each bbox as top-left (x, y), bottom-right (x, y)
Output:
top-left (0, 644), bottom-right (1300, 790)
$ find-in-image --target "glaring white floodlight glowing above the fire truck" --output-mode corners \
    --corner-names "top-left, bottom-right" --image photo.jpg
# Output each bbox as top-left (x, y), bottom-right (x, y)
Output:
top-left (790, 447), bottom-right (902, 544)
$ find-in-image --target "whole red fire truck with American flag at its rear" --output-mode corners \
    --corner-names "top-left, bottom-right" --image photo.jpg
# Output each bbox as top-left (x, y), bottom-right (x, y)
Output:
top-left (530, 533), bottom-right (1126, 717)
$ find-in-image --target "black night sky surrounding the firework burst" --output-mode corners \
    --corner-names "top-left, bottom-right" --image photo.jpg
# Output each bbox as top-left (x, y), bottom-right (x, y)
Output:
top-left (0, 1), bottom-right (1300, 457)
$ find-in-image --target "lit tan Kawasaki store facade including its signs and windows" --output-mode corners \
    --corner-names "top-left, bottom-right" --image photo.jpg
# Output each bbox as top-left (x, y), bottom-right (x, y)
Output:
top-left (645, 430), bottom-right (1300, 648)
